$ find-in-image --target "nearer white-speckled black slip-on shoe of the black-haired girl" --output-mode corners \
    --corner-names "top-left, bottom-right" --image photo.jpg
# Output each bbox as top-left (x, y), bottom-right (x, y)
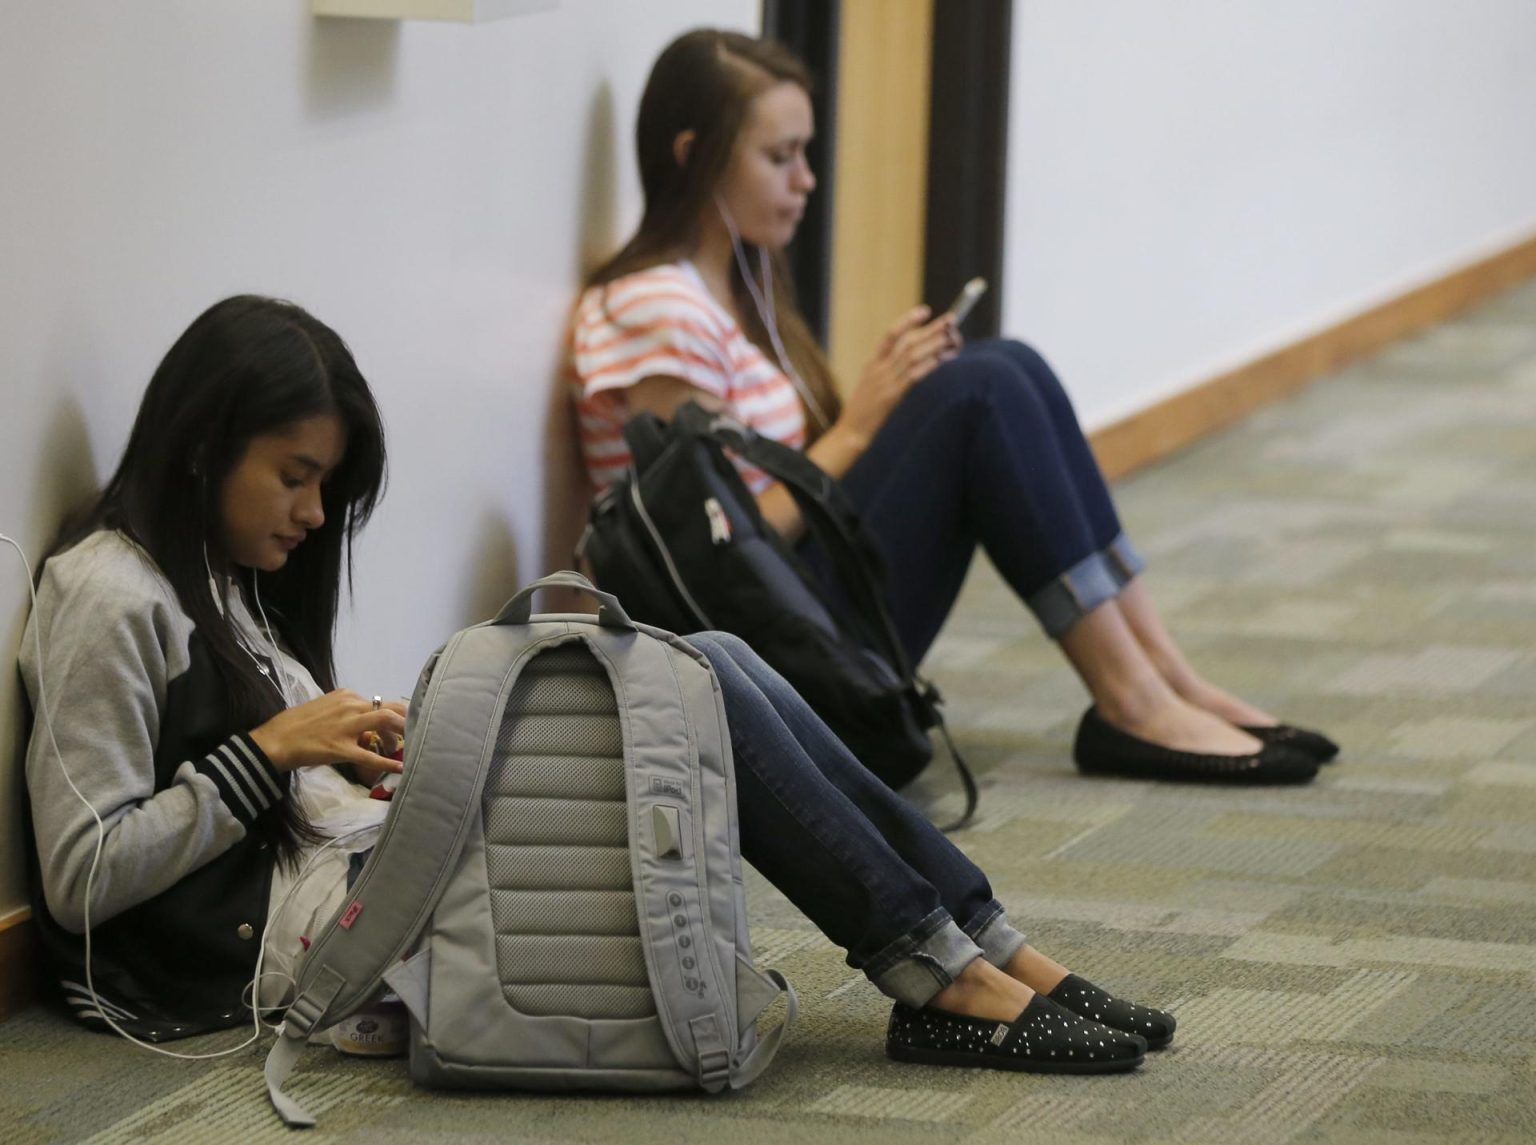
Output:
top-left (885, 994), bottom-right (1147, 1073)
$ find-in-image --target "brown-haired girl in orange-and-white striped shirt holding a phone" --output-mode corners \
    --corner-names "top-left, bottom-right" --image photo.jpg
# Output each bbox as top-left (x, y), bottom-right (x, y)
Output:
top-left (573, 31), bottom-right (1338, 782)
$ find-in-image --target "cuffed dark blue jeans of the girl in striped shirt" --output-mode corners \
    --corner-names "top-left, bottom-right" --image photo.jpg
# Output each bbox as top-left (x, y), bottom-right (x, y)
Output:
top-left (806, 340), bottom-right (1144, 664)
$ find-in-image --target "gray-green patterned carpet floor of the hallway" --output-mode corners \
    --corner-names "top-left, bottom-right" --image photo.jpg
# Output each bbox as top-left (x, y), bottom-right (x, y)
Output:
top-left (0, 284), bottom-right (1536, 1145)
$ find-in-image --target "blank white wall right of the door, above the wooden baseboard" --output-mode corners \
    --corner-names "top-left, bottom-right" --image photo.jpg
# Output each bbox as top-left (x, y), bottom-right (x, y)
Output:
top-left (1003, 0), bottom-right (1536, 426)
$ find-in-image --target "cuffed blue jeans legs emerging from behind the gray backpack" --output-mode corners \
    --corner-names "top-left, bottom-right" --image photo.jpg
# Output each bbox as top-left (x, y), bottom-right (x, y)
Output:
top-left (688, 632), bottom-right (1025, 1007)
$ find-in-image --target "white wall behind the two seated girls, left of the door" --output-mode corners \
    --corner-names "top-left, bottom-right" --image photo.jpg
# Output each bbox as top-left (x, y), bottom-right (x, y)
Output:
top-left (0, 0), bottom-right (759, 916)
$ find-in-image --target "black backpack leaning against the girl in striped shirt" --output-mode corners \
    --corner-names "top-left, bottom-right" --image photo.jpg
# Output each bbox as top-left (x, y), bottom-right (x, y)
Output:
top-left (578, 401), bottom-right (977, 830)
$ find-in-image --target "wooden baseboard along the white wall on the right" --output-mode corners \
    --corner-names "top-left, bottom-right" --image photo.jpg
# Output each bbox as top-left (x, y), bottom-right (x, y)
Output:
top-left (1089, 237), bottom-right (1536, 478)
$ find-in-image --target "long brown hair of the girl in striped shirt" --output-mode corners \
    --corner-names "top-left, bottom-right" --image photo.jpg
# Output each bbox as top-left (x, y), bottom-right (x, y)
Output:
top-left (587, 28), bottom-right (840, 438)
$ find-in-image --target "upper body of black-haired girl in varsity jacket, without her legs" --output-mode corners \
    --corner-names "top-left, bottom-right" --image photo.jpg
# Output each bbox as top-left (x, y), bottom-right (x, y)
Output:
top-left (22, 297), bottom-right (404, 1039)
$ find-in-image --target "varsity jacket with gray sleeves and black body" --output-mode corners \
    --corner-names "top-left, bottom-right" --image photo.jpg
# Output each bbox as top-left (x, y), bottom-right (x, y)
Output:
top-left (22, 532), bottom-right (286, 1040)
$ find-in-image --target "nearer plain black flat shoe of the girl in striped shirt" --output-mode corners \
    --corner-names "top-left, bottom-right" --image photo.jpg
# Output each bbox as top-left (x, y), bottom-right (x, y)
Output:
top-left (1072, 707), bottom-right (1318, 784)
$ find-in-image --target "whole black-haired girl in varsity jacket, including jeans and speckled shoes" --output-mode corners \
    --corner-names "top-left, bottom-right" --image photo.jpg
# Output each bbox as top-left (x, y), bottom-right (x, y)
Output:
top-left (22, 298), bottom-right (1174, 1073)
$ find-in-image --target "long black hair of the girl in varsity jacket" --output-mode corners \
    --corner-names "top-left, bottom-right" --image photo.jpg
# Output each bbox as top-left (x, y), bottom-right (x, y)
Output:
top-left (61, 295), bottom-right (386, 862)
